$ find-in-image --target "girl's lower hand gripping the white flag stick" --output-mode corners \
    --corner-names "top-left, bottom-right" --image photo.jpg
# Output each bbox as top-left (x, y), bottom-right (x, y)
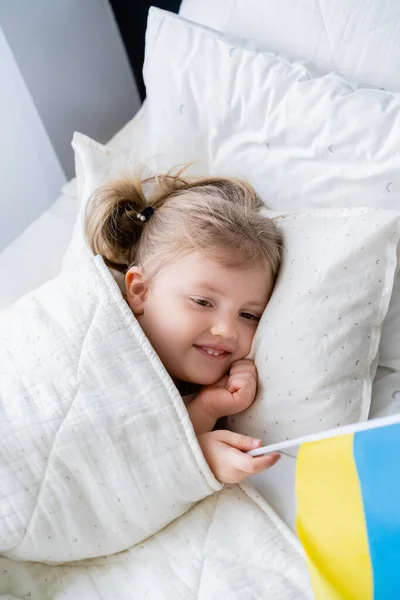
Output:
top-left (198, 430), bottom-right (280, 483)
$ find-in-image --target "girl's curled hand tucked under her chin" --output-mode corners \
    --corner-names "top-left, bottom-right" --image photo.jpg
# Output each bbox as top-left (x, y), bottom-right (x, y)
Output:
top-left (197, 359), bottom-right (257, 419)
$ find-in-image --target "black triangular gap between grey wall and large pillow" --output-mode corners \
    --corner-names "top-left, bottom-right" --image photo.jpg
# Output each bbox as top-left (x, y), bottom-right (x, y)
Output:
top-left (110, 0), bottom-right (181, 100)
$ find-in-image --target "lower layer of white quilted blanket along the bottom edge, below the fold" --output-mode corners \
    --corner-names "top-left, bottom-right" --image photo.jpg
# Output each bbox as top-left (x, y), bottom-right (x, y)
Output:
top-left (0, 486), bottom-right (312, 600)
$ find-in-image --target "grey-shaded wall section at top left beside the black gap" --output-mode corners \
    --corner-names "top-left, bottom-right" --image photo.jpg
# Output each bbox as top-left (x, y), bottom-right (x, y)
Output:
top-left (0, 0), bottom-right (140, 178)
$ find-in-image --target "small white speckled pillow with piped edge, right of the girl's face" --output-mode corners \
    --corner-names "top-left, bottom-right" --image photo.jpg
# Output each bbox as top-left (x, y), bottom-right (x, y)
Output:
top-left (229, 208), bottom-right (400, 443)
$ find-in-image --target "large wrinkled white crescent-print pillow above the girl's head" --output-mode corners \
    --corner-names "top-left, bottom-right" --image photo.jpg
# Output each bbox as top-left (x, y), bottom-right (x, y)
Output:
top-left (145, 4), bottom-right (400, 422)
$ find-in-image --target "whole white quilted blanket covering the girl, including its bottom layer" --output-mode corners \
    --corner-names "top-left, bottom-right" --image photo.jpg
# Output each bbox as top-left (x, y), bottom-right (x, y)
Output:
top-left (0, 257), bottom-right (310, 600)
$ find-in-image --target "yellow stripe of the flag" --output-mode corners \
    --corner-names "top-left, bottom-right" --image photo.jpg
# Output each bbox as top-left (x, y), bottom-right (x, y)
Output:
top-left (296, 434), bottom-right (373, 600)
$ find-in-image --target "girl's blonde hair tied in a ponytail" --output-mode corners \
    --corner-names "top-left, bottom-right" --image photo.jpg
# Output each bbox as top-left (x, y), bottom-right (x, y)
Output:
top-left (86, 169), bottom-right (283, 278)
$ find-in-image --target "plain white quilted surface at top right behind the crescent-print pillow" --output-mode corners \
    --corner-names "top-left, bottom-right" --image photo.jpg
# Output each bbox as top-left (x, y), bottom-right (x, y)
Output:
top-left (180, 0), bottom-right (400, 92)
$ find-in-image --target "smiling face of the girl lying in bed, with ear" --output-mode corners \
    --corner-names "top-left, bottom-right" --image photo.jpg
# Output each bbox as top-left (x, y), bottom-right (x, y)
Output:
top-left (126, 252), bottom-right (273, 385)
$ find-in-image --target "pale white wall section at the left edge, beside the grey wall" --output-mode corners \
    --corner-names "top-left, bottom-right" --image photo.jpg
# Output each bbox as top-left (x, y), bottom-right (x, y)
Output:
top-left (0, 28), bottom-right (66, 251)
